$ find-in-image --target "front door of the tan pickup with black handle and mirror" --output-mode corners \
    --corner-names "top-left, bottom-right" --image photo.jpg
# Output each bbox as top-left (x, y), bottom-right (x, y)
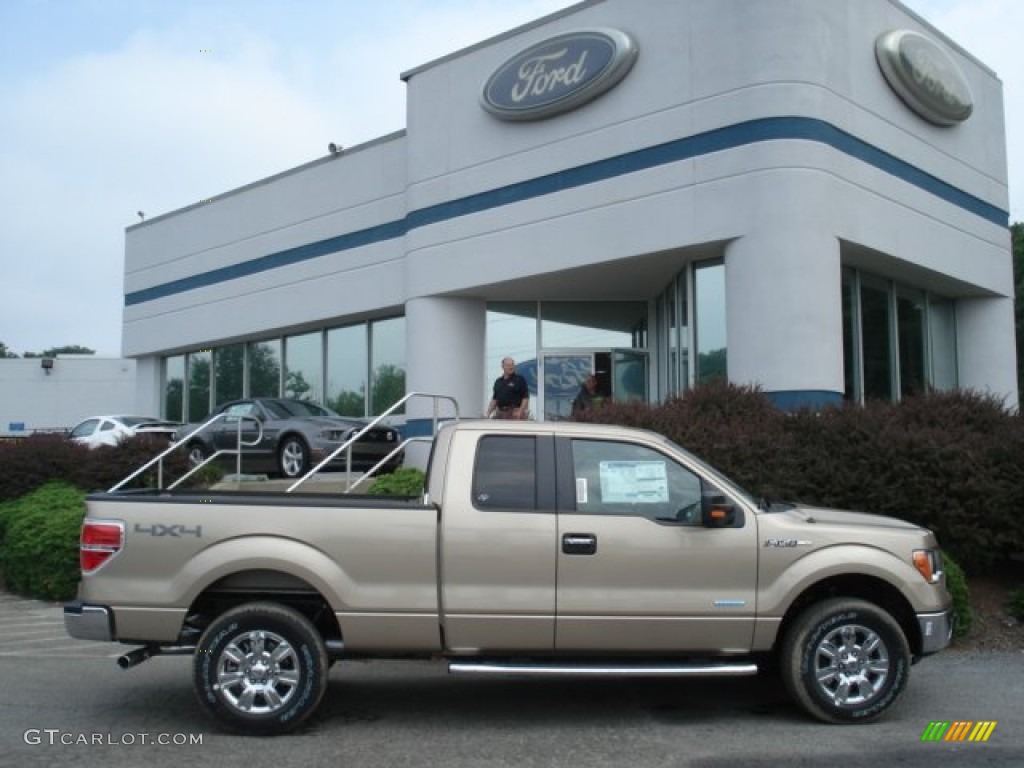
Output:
top-left (555, 437), bottom-right (758, 652)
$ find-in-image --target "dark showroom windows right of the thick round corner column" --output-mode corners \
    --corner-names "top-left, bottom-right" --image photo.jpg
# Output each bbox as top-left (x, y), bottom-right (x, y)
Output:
top-left (842, 268), bottom-right (957, 402)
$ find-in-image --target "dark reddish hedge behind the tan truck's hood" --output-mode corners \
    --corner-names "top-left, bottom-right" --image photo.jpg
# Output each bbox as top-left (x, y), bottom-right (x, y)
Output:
top-left (588, 384), bottom-right (1024, 574)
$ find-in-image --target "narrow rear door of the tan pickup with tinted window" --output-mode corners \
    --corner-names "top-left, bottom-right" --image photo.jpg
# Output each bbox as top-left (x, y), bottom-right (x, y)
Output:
top-left (440, 432), bottom-right (557, 652)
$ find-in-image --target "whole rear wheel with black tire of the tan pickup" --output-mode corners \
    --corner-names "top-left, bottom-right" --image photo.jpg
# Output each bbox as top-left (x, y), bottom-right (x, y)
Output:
top-left (193, 602), bottom-right (328, 736)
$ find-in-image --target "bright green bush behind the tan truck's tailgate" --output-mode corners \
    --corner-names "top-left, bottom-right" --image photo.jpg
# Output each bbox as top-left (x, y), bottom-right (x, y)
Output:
top-left (0, 482), bottom-right (85, 600)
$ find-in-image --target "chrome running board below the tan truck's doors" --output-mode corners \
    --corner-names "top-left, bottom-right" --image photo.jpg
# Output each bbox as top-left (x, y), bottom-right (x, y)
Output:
top-left (449, 662), bottom-right (758, 677)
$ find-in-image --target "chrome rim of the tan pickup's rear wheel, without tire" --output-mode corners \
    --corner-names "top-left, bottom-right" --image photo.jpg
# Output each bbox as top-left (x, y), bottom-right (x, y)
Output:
top-left (216, 630), bottom-right (302, 715)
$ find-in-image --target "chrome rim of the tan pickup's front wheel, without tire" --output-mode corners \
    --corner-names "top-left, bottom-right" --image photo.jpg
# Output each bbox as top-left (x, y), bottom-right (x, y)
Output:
top-left (814, 625), bottom-right (889, 706)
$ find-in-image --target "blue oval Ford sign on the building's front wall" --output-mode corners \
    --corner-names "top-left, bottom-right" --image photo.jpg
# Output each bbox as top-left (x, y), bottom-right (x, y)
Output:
top-left (482, 29), bottom-right (637, 120)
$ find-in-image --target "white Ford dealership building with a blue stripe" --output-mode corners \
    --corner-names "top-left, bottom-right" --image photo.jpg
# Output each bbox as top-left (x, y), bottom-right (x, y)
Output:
top-left (123, 0), bottom-right (1018, 432)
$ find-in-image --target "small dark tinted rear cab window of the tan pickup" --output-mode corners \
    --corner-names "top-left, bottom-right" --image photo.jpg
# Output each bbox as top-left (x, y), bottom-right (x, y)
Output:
top-left (473, 435), bottom-right (537, 510)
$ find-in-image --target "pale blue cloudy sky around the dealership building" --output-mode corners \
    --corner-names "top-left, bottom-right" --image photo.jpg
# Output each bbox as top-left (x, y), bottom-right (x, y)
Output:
top-left (0, 0), bottom-right (1024, 356)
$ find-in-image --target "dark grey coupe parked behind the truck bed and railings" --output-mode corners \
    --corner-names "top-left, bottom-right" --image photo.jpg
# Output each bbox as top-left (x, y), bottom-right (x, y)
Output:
top-left (177, 397), bottom-right (403, 477)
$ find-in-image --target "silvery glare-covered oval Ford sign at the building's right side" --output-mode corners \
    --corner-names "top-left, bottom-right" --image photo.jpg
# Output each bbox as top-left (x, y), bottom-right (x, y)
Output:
top-left (874, 30), bottom-right (974, 125)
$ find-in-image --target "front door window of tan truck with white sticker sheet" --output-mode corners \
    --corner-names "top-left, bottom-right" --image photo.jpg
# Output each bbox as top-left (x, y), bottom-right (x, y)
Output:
top-left (572, 440), bottom-right (702, 525)
